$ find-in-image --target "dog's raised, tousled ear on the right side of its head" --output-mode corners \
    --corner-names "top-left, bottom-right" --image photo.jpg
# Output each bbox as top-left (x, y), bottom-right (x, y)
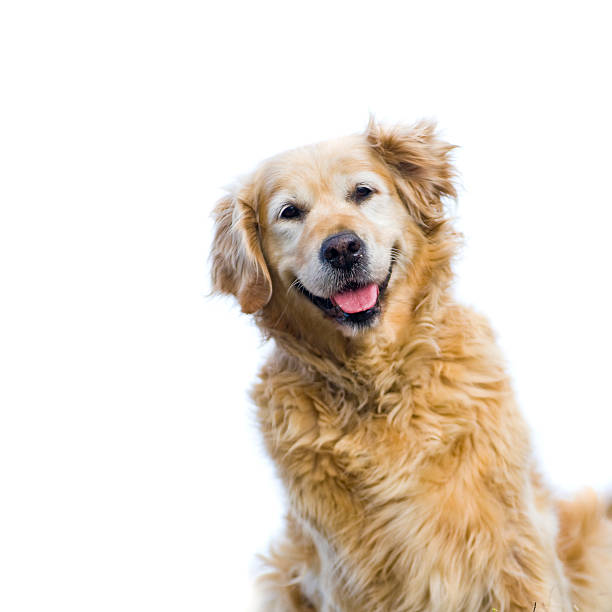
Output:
top-left (366, 118), bottom-right (457, 233)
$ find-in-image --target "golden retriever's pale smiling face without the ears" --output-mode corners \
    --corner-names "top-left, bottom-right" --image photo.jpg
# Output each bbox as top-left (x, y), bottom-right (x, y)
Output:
top-left (259, 137), bottom-right (412, 328)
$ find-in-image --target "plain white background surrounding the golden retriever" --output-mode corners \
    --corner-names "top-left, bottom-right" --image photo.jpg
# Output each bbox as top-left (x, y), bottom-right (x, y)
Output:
top-left (0, 0), bottom-right (612, 612)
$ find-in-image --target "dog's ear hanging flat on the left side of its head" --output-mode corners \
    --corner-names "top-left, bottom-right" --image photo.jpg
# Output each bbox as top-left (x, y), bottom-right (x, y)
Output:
top-left (211, 188), bottom-right (272, 314)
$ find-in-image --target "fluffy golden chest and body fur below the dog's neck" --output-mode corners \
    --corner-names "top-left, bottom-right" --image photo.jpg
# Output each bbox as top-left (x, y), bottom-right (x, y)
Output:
top-left (254, 310), bottom-right (569, 611)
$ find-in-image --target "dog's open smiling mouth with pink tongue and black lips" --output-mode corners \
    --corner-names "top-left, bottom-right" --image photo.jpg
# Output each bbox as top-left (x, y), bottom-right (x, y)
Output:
top-left (296, 262), bottom-right (393, 327)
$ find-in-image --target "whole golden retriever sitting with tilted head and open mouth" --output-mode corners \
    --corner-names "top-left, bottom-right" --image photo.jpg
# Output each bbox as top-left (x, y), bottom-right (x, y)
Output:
top-left (211, 119), bottom-right (612, 612)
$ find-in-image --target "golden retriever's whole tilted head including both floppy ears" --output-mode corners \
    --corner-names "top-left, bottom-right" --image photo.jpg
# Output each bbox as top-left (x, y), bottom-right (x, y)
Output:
top-left (212, 121), bottom-right (455, 334)
